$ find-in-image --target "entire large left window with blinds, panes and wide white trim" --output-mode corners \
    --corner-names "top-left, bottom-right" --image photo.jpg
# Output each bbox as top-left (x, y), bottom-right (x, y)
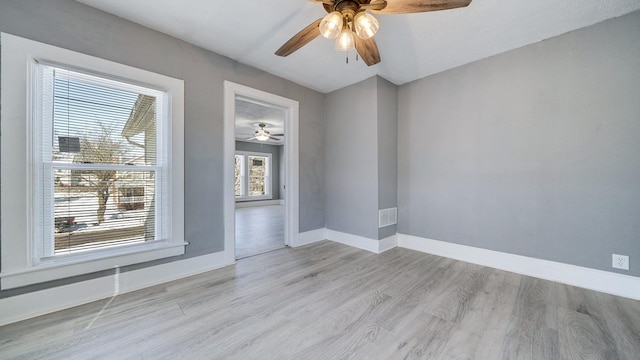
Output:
top-left (0, 33), bottom-right (186, 289)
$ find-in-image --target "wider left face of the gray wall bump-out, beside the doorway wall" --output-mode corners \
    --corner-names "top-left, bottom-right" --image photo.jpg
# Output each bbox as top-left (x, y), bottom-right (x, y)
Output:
top-left (325, 77), bottom-right (378, 239)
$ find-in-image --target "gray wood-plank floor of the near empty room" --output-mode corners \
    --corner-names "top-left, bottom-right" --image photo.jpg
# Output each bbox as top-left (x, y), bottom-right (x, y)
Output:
top-left (0, 241), bottom-right (640, 360)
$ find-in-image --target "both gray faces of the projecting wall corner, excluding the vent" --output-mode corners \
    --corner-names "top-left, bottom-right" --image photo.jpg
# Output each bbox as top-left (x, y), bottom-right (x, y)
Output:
top-left (325, 76), bottom-right (398, 239)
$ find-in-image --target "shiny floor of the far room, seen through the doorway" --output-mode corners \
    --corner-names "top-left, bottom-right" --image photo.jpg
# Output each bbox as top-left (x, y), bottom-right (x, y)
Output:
top-left (236, 205), bottom-right (284, 259)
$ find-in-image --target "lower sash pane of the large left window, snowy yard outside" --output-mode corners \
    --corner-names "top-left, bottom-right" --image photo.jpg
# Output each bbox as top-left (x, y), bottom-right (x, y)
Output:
top-left (53, 169), bottom-right (155, 255)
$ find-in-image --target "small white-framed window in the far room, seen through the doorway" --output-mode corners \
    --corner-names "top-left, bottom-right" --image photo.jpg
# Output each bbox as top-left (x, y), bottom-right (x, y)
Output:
top-left (235, 151), bottom-right (272, 200)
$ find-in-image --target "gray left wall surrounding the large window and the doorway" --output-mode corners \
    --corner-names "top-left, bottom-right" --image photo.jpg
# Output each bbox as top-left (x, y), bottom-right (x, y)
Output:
top-left (0, 0), bottom-right (325, 297)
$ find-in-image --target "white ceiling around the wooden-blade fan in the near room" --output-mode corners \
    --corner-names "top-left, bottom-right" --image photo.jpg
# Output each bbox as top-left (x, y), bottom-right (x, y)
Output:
top-left (78, 0), bottom-right (640, 92)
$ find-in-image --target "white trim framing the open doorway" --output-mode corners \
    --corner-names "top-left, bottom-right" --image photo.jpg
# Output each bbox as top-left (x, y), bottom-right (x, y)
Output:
top-left (223, 81), bottom-right (300, 264)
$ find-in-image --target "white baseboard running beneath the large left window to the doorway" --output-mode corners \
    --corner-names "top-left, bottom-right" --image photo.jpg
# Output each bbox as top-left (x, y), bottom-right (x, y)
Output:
top-left (0, 251), bottom-right (227, 326)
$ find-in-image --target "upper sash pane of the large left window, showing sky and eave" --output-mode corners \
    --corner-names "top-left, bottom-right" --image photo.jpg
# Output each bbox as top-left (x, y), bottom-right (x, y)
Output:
top-left (48, 67), bottom-right (156, 165)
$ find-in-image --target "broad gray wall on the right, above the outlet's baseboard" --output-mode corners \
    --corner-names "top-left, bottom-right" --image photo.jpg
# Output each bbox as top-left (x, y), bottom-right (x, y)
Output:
top-left (398, 12), bottom-right (640, 276)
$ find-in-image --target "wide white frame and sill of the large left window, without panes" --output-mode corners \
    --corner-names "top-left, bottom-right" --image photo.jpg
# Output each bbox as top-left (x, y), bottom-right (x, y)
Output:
top-left (0, 33), bottom-right (187, 289)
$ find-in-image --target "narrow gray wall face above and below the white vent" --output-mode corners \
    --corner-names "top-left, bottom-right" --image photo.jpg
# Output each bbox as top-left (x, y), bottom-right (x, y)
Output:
top-left (376, 77), bottom-right (398, 239)
